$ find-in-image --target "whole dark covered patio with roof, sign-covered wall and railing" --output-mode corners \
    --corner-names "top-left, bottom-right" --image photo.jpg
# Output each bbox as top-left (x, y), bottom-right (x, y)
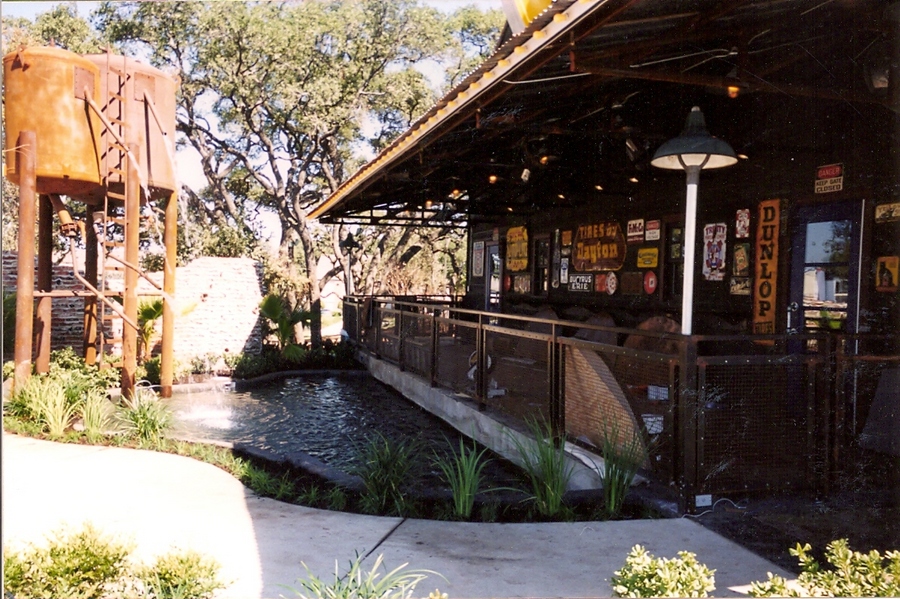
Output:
top-left (311, 0), bottom-right (900, 511)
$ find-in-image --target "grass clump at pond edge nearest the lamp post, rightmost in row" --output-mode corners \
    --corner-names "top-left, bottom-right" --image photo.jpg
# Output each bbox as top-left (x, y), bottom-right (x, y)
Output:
top-left (600, 422), bottom-right (647, 518)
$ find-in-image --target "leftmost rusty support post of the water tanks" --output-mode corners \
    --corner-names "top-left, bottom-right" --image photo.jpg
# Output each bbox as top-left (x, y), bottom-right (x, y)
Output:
top-left (13, 131), bottom-right (37, 390)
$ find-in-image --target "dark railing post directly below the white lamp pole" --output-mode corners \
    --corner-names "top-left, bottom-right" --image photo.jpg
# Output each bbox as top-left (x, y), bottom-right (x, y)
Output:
top-left (678, 336), bottom-right (700, 513)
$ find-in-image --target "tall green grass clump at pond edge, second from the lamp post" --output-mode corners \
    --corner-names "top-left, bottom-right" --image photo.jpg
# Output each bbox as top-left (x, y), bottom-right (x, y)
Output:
top-left (509, 420), bottom-right (573, 517)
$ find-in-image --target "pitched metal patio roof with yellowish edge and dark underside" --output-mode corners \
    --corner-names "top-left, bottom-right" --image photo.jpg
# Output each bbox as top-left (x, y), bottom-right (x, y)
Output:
top-left (310, 0), bottom-right (890, 226)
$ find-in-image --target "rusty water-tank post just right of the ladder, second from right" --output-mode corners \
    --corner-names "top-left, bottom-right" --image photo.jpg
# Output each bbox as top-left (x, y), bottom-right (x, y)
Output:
top-left (122, 143), bottom-right (141, 400)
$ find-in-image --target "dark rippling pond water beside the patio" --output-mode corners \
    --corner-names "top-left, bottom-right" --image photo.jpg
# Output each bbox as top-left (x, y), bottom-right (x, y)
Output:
top-left (169, 374), bottom-right (522, 487)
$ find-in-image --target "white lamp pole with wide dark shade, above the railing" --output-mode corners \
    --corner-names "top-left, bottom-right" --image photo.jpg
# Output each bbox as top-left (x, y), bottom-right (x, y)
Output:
top-left (650, 106), bottom-right (737, 335)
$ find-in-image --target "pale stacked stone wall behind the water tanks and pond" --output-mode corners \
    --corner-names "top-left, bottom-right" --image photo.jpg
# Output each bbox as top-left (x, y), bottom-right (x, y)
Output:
top-left (3, 252), bottom-right (263, 363)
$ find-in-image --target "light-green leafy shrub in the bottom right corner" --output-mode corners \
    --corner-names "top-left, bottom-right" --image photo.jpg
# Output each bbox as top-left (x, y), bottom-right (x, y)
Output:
top-left (749, 539), bottom-right (900, 597)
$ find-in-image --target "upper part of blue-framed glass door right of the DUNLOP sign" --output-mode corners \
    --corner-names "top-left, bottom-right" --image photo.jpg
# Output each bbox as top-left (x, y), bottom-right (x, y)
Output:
top-left (787, 202), bottom-right (862, 333)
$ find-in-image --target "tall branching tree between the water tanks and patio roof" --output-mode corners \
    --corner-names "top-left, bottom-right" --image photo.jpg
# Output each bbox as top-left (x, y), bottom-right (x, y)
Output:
top-left (96, 0), bottom-right (460, 343)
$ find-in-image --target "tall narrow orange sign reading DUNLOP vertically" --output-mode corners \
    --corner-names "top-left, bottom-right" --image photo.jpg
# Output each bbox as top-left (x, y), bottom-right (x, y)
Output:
top-left (753, 200), bottom-right (781, 335)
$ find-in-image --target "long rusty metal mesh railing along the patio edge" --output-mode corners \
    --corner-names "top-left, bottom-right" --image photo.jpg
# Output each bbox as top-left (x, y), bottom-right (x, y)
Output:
top-left (344, 298), bottom-right (900, 510)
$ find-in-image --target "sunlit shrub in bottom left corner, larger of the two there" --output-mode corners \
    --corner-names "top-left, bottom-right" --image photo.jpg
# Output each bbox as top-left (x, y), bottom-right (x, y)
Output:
top-left (3, 524), bottom-right (131, 599)
